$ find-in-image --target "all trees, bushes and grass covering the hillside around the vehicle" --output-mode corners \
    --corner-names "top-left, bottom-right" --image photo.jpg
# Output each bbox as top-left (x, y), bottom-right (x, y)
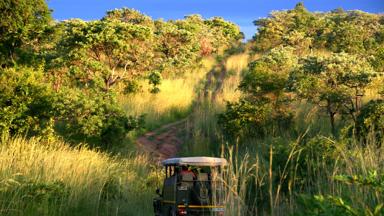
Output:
top-left (0, 0), bottom-right (384, 216)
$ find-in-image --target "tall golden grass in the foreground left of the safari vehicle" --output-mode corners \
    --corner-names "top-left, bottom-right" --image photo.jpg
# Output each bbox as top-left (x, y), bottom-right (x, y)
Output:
top-left (0, 138), bottom-right (162, 216)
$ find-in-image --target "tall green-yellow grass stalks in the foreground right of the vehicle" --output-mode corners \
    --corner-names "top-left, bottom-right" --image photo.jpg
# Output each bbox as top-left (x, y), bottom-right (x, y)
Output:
top-left (219, 132), bottom-right (384, 216)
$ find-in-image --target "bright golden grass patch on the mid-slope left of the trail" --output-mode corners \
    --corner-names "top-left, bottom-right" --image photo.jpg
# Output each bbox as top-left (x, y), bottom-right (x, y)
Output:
top-left (119, 59), bottom-right (214, 129)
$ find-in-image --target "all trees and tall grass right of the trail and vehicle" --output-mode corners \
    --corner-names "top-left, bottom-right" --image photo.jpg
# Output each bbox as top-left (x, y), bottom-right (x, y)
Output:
top-left (209, 3), bottom-right (384, 215)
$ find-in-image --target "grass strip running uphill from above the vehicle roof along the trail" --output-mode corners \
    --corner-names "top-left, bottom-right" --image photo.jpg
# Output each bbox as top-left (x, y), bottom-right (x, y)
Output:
top-left (181, 53), bottom-right (249, 155)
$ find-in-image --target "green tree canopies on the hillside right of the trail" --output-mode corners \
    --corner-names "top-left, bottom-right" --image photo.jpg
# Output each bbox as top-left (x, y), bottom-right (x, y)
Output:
top-left (219, 3), bottom-right (384, 140)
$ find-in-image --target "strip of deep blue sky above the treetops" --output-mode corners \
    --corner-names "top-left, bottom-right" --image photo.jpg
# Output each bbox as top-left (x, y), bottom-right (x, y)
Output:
top-left (48, 0), bottom-right (384, 39)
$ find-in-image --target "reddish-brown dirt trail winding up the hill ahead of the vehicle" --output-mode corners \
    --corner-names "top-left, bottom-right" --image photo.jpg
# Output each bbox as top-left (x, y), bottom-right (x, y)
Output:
top-left (136, 62), bottom-right (226, 163)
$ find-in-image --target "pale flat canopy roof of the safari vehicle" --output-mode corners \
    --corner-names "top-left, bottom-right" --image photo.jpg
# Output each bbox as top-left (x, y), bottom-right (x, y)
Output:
top-left (161, 157), bottom-right (227, 167)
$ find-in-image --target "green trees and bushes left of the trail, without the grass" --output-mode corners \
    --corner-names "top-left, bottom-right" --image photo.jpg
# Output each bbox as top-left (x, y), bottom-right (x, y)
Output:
top-left (0, 1), bottom-right (241, 148)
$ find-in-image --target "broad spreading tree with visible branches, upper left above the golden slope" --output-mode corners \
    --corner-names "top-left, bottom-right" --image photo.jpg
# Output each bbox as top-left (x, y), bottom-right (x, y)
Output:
top-left (58, 20), bottom-right (153, 91)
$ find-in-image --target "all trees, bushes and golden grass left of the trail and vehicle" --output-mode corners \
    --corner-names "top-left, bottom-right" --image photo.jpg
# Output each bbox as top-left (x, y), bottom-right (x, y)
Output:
top-left (0, 0), bottom-right (242, 215)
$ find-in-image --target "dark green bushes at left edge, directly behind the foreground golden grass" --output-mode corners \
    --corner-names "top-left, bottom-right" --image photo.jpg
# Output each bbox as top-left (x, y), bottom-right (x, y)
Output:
top-left (0, 68), bottom-right (143, 147)
